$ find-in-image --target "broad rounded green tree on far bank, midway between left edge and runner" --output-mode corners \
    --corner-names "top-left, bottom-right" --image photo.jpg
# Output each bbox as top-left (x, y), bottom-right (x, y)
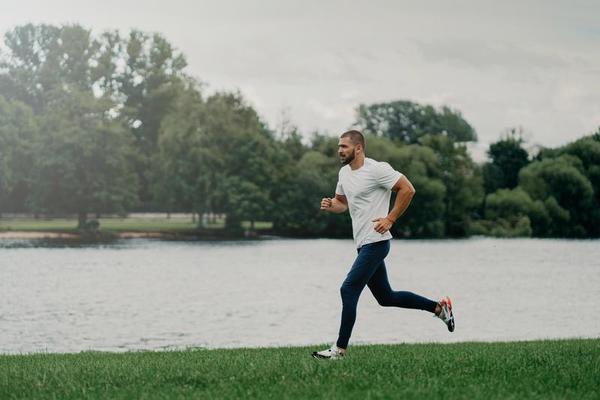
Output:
top-left (157, 87), bottom-right (278, 231)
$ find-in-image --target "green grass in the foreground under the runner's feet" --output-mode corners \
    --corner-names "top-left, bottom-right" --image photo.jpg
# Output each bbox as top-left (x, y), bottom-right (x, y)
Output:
top-left (0, 339), bottom-right (600, 400)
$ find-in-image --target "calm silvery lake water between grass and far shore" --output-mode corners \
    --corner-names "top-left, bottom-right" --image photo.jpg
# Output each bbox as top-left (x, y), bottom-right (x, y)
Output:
top-left (0, 239), bottom-right (600, 353)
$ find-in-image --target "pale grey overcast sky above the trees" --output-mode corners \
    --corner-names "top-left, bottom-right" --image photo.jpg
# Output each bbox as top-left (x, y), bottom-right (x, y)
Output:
top-left (0, 0), bottom-right (600, 158)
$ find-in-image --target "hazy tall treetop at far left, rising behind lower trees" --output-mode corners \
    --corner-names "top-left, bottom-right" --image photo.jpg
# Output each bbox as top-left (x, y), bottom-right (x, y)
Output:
top-left (0, 24), bottom-right (116, 114)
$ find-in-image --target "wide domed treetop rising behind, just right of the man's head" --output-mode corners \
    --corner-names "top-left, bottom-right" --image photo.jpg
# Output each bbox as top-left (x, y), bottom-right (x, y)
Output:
top-left (355, 101), bottom-right (477, 144)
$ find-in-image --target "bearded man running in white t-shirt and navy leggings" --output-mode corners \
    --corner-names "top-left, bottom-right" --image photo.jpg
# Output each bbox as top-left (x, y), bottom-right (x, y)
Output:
top-left (312, 130), bottom-right (454, 359)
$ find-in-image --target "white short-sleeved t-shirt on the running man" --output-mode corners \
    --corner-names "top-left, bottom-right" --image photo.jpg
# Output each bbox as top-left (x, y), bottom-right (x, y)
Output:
top-left (335, 158), bottom-right (402, 248)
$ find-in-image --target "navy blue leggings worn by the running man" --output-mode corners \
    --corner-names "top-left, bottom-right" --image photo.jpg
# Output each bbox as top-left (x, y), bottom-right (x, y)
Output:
top-left (336, 240), bottom-right (437, 349)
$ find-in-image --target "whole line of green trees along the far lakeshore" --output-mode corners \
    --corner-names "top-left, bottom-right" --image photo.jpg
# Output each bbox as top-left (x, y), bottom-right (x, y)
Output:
top-left (0, 24), bottom-right (600, 237)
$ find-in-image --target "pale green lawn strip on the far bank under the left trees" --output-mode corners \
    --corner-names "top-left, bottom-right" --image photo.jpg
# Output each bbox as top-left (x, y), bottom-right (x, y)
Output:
top-left (0, 217), bottom-right (272, 232)
